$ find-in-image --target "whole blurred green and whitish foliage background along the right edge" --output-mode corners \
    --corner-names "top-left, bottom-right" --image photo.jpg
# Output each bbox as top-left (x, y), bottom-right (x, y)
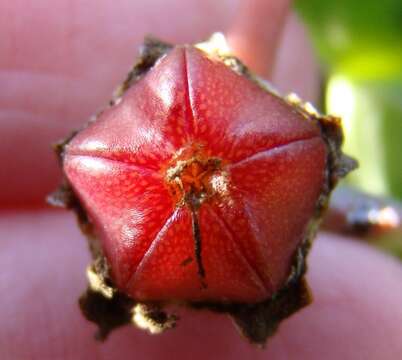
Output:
top-left (296, 0), bottom-right (402, 200)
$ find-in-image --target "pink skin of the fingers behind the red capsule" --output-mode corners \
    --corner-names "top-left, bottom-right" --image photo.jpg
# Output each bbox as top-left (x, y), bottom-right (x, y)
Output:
top-left (0, 0), bottom-right (402, 360)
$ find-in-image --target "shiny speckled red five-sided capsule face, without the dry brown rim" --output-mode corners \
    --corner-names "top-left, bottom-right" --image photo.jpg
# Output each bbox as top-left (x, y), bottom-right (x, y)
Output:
top-left (64, 47), bottom-right (327, 303)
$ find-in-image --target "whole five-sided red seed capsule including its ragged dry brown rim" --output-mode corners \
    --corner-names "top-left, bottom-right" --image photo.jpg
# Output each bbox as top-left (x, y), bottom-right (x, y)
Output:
top-left (49, 34), bottom-right (353, 344)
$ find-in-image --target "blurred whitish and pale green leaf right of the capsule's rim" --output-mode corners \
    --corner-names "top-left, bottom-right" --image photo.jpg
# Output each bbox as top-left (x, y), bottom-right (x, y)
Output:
top-left (327, 74), bottom-right (402, 199)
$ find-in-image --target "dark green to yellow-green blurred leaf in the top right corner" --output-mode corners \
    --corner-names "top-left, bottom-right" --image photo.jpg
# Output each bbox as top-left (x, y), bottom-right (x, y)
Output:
top-left (296, 0), bottom-right (402, 79)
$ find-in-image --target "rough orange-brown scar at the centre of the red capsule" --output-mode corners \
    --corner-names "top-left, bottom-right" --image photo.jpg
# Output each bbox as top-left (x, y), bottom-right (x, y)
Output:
top-left (165, 148), bottom-right (225, 209)
